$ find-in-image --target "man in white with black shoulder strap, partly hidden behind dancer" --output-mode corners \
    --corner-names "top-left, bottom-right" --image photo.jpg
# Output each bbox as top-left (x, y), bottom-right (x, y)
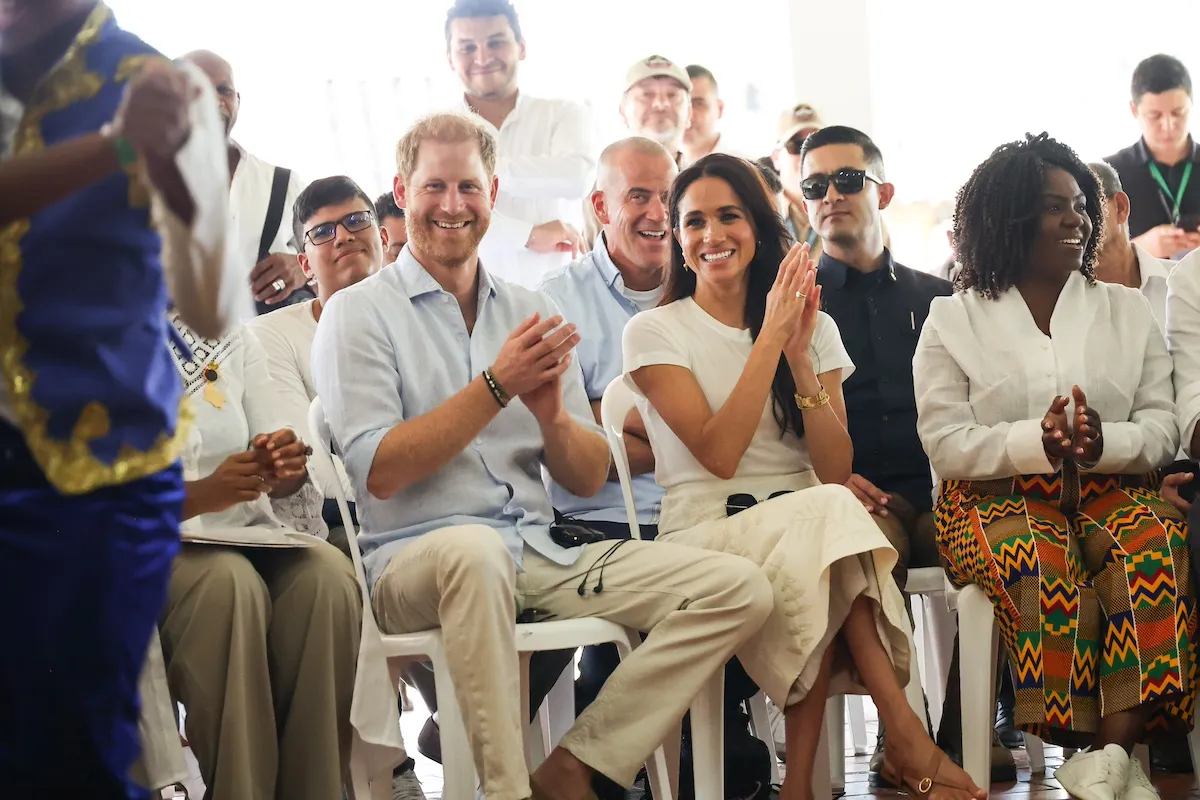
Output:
top-left (184, 50), bottom-right (313, 314)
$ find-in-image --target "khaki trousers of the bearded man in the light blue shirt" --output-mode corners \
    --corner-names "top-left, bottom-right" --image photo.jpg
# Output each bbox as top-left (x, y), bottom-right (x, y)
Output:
top-left (372, 525), bottom-right (772, 800)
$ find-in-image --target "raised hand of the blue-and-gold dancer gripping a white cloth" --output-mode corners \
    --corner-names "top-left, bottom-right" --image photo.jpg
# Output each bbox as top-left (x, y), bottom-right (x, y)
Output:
top-left (112, 61), bottom-right (199, 158)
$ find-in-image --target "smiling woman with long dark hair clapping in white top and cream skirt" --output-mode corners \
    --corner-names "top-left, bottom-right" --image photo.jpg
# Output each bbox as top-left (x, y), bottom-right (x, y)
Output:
top-left (624, 154), bottom-right (983, 800)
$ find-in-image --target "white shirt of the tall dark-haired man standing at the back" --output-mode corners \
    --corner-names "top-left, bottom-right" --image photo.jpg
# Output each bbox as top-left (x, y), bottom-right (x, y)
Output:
top-left (460, 92), bottom-right (596, 288)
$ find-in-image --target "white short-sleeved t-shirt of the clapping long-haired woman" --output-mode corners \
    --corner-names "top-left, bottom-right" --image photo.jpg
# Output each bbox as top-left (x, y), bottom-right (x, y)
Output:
top-left (623, 297), bottom-right (854, 491)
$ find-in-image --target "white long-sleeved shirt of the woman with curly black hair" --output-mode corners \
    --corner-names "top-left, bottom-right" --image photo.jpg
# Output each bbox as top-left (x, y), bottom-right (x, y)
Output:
top-left (912, 272), bottom-right (1180, 480)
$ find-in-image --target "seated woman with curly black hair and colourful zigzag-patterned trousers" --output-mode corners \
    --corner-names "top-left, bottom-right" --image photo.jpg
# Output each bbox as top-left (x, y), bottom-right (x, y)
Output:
top-left (913, 134), bottom-right (1196, 800)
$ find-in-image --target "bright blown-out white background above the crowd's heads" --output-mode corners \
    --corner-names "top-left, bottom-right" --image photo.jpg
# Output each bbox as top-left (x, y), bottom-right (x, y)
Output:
top-left (108, 0), bottom-right (1200, 269)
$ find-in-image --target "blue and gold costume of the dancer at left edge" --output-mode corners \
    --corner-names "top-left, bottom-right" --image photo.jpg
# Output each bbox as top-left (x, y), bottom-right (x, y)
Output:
top-left (0, 4), bottom-right (185, 798)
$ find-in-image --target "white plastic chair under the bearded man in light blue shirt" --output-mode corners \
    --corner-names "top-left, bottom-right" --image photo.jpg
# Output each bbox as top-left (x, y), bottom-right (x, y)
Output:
top-left (308, 398), bottom-right (681, 800)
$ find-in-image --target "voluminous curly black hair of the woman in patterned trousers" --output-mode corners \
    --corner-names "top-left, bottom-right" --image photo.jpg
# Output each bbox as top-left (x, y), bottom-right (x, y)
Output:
top-left (954, 133), bottom-right (1104, 300)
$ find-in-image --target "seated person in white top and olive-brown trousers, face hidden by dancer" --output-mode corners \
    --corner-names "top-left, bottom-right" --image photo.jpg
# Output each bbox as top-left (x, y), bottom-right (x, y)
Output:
top-left (148, 319), bottom-right (404, 800)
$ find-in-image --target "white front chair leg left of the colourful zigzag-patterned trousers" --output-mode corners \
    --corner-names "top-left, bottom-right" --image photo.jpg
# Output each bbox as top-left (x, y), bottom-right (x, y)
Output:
top-left (959, 585), bottom-right (1000, 787)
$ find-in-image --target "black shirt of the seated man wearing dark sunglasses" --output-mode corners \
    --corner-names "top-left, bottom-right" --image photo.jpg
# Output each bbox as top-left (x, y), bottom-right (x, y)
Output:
top-left (817, 251), bottom-right (953, 511)
